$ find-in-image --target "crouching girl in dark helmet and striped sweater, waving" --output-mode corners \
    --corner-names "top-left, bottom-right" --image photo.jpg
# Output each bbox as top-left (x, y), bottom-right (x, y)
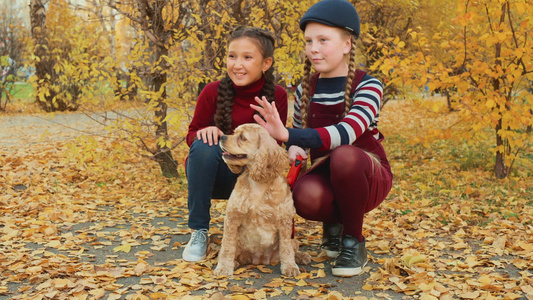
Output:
top-left (252, 0), bottom-right (392, 276)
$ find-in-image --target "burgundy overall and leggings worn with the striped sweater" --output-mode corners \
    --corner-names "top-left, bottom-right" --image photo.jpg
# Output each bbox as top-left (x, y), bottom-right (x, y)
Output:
top-left (293, 70), bottom-right (392, 241)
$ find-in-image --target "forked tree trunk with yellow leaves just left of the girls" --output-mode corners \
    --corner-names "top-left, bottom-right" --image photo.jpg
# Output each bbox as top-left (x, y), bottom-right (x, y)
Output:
top-left (108, 0), bottom-right (200, 177)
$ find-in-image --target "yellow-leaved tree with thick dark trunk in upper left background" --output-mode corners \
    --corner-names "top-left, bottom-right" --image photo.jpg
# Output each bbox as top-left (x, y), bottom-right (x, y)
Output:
top-left (29, 0), bottom-right (111, 112)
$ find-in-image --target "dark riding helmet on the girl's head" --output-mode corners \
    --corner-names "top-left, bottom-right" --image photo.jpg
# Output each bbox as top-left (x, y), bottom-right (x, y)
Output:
top-left (300, 0), bottom-right (361, 38)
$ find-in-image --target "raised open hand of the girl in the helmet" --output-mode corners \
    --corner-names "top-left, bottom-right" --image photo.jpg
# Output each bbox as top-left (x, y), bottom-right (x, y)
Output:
top-left (250, 96), bottom-right (289, 142)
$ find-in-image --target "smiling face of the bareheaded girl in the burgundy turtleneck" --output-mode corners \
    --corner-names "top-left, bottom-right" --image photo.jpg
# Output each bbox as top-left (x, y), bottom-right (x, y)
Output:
top-left (226, 37), bottom-right (272, 86)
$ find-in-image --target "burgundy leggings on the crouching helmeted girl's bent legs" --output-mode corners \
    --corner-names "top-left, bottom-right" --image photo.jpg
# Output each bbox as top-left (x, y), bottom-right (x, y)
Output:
top-left (293, 145), bottom-right (392, 241)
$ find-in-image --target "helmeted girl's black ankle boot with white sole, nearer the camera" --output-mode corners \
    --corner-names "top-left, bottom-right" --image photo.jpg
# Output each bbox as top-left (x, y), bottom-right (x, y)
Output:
top-left (331, 234), bottom-right (368, 277)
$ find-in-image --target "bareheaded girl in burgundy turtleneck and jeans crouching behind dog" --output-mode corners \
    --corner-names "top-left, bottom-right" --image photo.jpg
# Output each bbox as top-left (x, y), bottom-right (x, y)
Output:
top-left (183, 27), bottom-right (287, 261)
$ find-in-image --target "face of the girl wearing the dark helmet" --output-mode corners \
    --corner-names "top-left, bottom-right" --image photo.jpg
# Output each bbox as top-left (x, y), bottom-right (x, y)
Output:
top-left (304, 22), bottom-right (352, 77)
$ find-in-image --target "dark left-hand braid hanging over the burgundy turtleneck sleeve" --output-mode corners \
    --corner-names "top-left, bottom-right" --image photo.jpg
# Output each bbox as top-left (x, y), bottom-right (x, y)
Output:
top-left (215, 75), bottom-right (235, 134)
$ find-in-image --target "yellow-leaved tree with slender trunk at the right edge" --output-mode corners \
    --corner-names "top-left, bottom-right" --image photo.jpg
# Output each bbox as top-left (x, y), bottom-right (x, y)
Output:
top-left (375, 0), bottom-right (533, 178)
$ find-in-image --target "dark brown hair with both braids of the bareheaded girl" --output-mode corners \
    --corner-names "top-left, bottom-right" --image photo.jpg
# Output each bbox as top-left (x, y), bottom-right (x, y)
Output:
top-left (215, 26), bottom-right (276, 134)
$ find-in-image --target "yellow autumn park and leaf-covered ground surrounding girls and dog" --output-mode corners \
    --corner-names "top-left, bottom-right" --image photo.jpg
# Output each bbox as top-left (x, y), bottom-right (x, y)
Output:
top-left (0, 0), bottom-right (533, 299)
